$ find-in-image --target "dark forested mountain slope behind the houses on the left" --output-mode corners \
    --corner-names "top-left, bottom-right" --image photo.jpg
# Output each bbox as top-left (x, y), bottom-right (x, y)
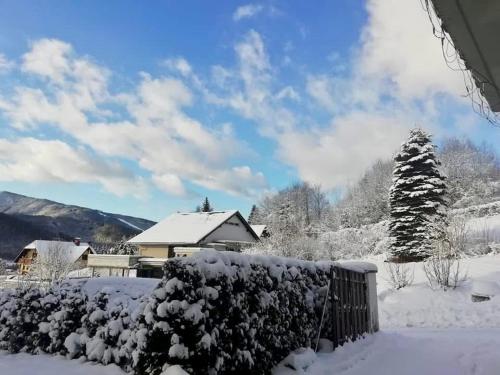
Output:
top-left (0, 191), bottom-right (155, 259)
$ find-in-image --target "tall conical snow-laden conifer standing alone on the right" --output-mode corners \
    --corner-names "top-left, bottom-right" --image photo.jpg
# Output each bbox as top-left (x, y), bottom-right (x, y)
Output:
top-left (389, 129), bottom-right (447, 261)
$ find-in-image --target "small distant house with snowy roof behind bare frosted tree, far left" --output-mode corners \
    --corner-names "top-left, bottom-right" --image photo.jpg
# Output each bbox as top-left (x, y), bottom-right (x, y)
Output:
top-left (15, 238), bottom-right (95, 275)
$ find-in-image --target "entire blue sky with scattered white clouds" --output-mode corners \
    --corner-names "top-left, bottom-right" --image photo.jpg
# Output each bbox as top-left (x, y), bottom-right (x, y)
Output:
top-left (0, 0), bottom-right (500, 220)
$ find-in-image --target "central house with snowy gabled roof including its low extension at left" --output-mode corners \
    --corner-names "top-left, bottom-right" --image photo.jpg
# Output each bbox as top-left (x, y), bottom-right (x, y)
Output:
top-left (88, 211), bottom-right (259, 278)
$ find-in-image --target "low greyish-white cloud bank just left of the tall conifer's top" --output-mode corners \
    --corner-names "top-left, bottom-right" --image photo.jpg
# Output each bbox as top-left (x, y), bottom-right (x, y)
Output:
top-left (279, 112), bottom-right (410, 189)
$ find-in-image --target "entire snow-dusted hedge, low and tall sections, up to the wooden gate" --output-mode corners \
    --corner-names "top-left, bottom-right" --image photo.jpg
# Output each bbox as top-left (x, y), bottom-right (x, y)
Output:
top-left (0, 251), bottom-right (334, 375)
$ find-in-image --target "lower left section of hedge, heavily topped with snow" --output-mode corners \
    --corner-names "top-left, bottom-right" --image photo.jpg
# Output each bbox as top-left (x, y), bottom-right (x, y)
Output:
top-left (0, 278), bottom-right (159, 369)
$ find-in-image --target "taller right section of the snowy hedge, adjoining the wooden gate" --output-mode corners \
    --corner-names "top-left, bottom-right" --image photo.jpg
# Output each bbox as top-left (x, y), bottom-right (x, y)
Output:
top-left (134, 251), bottom-right (333, 374)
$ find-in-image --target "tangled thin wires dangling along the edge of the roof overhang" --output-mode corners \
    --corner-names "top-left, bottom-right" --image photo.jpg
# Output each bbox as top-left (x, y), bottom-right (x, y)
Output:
top-left (420, 0), bottom-right (500, 127)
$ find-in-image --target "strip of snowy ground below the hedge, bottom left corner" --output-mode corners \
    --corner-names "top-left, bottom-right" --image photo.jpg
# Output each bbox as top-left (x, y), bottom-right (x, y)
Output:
top-left (0, 352), bottom-right (125, 375)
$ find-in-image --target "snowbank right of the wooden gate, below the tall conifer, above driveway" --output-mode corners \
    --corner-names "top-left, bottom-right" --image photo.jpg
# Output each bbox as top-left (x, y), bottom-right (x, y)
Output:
top-left (371, 255), bottom-right (500, 329)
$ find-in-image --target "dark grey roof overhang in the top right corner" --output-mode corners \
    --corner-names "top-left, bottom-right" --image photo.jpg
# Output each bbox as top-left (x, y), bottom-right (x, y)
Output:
top-left (431, 0), bottom-right (500, 112)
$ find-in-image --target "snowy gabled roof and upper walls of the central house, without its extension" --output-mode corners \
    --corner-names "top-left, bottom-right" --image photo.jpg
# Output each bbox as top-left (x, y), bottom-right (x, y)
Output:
top-left (128, 211), bottom-right (259, 258)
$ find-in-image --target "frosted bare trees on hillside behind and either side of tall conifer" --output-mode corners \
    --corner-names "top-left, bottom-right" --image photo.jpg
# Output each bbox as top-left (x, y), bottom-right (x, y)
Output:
top-left (249, 138), bottom-right (500, 259)
